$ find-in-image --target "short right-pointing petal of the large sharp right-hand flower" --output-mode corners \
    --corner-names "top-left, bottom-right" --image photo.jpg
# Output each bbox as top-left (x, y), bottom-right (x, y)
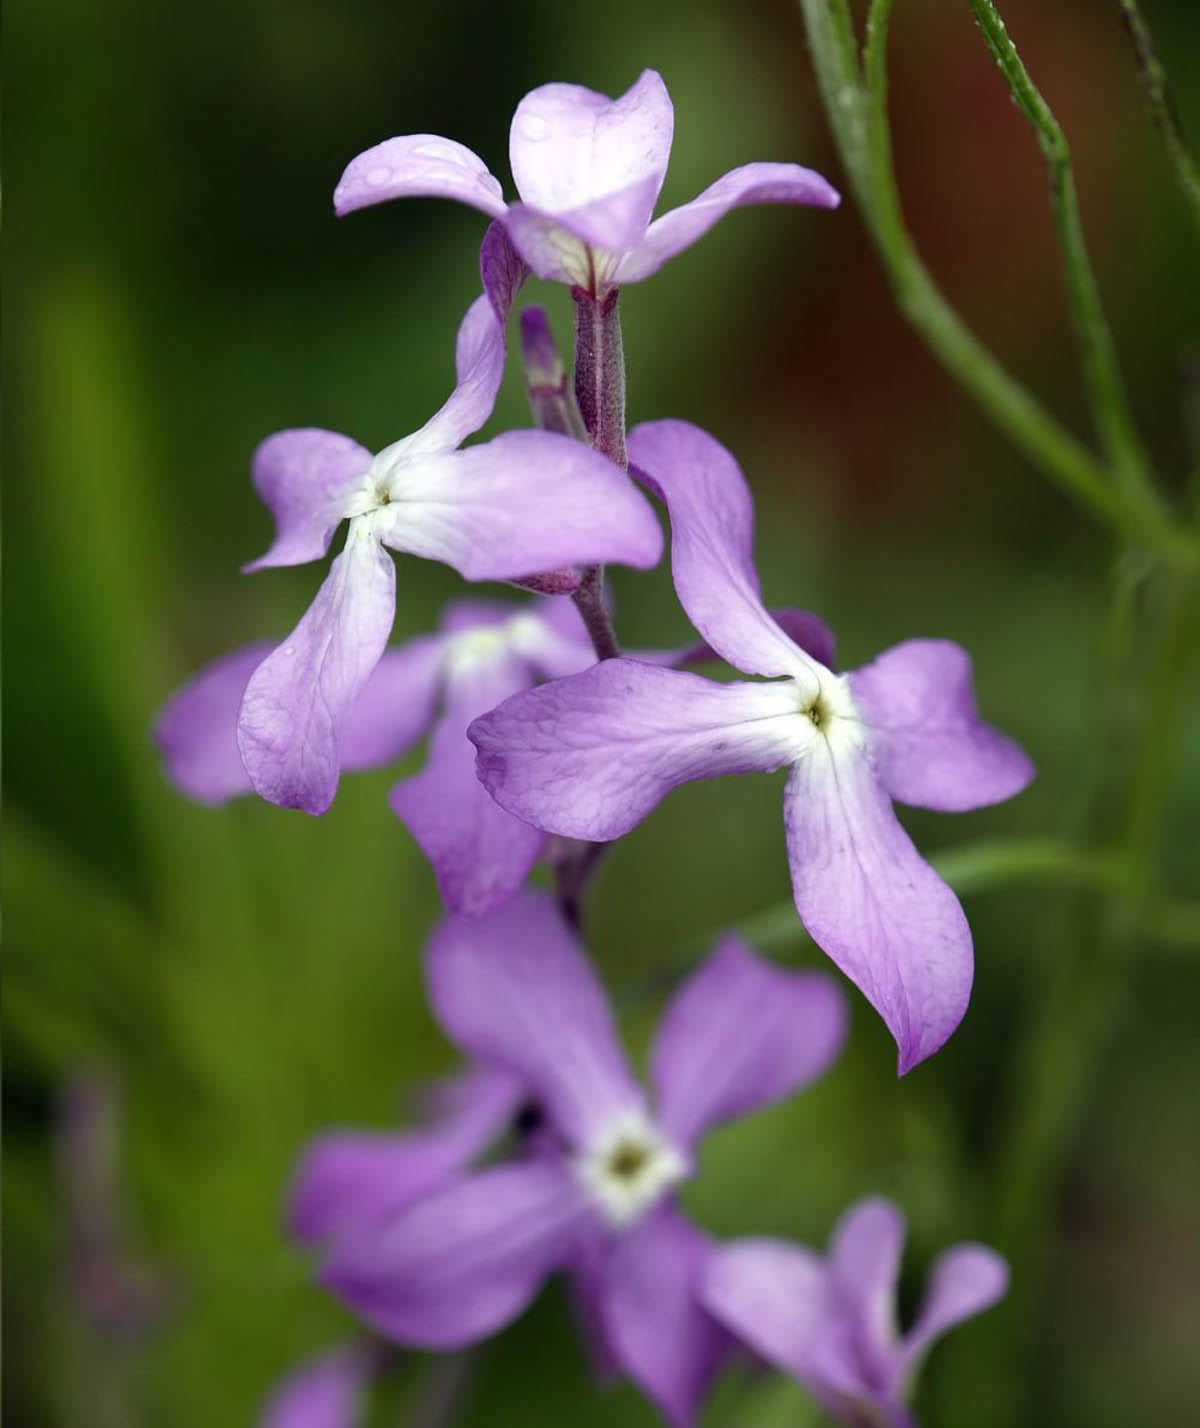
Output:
top-left (850, 640), bottom-right (1033, 813)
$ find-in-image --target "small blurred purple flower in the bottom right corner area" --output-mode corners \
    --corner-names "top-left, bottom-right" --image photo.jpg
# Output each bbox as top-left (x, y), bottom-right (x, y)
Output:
top-left (701, 1198), bottom-right (1009, 1428)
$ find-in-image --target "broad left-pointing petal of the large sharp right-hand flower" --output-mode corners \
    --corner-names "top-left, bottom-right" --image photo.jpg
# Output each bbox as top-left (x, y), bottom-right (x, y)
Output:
top-left (467, 660), bottom-right (803, 843)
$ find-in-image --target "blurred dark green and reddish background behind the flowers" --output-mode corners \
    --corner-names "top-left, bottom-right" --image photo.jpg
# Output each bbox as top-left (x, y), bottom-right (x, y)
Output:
top-left (6, 0), bottom-right (1200, 1428)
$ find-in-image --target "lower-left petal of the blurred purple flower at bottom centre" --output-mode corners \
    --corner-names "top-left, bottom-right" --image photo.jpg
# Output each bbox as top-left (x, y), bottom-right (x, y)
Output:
top-left (320, 1160), bottom-right (591, 1349)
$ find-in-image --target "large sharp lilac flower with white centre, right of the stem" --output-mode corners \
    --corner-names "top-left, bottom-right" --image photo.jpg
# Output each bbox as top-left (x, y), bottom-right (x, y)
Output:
top-left (469, 421), bottom-right (1033, 1074)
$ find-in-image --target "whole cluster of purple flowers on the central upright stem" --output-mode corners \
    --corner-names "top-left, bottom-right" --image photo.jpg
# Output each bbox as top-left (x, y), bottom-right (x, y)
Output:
top-left (157, 71), bottom-right (1031, 1428)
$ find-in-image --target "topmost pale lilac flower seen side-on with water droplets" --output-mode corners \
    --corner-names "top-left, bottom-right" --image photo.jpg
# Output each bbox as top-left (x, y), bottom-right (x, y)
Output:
top-left (333, 70), bottom-right (839, 297)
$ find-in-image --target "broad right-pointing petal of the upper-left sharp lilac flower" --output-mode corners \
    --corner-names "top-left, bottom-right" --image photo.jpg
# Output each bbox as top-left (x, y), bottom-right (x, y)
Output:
top-left (379, 431), bottom-right (663, 580)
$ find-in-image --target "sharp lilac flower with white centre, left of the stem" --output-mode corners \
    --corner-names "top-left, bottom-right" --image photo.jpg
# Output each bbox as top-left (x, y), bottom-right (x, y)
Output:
top-left (237, 288), bottom-right (661, 814)
